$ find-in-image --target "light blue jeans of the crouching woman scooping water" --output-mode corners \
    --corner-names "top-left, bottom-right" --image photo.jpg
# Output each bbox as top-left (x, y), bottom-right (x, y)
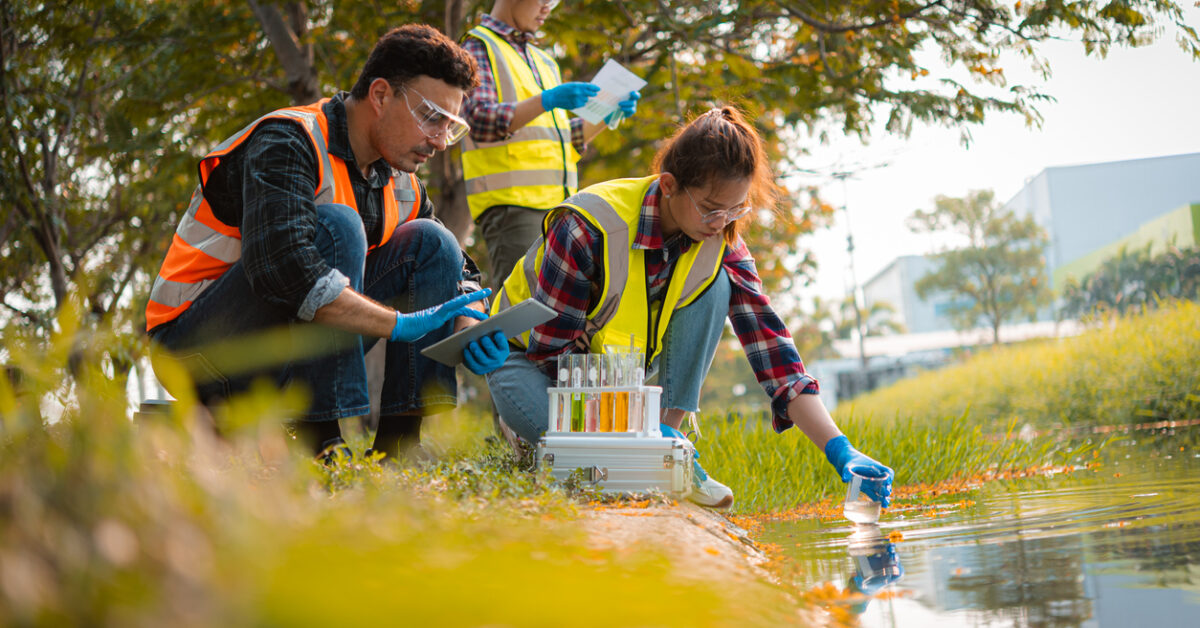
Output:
top-left (487, 269), bottom-right (732, 443)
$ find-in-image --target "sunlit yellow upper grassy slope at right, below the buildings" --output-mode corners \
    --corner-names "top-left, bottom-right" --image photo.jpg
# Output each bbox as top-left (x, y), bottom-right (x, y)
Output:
top-left (835, 301), bottom-right (1200, 427)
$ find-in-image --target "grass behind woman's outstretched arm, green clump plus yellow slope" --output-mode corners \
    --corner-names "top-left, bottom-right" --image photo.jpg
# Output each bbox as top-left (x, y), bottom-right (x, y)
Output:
top-left (700, 301), bottom-right (1200, 512)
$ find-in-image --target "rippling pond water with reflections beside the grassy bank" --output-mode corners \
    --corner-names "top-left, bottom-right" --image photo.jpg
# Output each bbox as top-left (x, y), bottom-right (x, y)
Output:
top-left (762, 438), bottom-right (1200, 628)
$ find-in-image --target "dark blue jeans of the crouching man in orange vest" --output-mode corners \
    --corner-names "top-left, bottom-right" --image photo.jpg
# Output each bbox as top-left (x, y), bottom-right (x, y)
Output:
top-left (150, 204), bottom-right (463, 420)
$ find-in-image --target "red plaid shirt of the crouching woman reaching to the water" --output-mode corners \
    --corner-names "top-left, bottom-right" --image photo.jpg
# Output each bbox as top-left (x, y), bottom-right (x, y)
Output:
top-left (526, 176), bottom-right (818, 432)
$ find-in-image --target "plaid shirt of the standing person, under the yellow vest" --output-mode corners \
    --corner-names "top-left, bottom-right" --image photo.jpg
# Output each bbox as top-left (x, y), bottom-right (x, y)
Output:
top-left (462, 13), bottom-right (587, 155)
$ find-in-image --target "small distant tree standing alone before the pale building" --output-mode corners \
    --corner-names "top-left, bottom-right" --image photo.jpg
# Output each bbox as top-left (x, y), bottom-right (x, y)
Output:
top-left (908, 190), bottom-right (1050, 345)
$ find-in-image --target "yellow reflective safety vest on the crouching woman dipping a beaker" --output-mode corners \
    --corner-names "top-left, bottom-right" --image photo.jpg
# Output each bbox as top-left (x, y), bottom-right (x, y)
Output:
top-left (492, 177), bottom-right (725, 364)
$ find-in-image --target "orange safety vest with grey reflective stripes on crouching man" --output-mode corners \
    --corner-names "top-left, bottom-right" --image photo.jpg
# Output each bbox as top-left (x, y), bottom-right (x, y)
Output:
top-left (146, 98), bottom-right (421, 331)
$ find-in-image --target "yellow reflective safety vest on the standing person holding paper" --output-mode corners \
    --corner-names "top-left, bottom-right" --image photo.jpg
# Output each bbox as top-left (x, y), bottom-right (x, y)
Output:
top-left (462, 26), bottom-right (580, 220)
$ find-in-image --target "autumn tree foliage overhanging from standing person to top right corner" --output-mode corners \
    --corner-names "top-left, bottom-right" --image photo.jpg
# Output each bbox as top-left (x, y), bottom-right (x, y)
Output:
top-left (545, 0), bottom-right (1200, 293)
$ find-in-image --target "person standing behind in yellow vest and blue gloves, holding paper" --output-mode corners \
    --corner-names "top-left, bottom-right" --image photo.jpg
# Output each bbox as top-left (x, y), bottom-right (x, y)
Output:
top-left (462, 0), bottom-right (641, 287)
